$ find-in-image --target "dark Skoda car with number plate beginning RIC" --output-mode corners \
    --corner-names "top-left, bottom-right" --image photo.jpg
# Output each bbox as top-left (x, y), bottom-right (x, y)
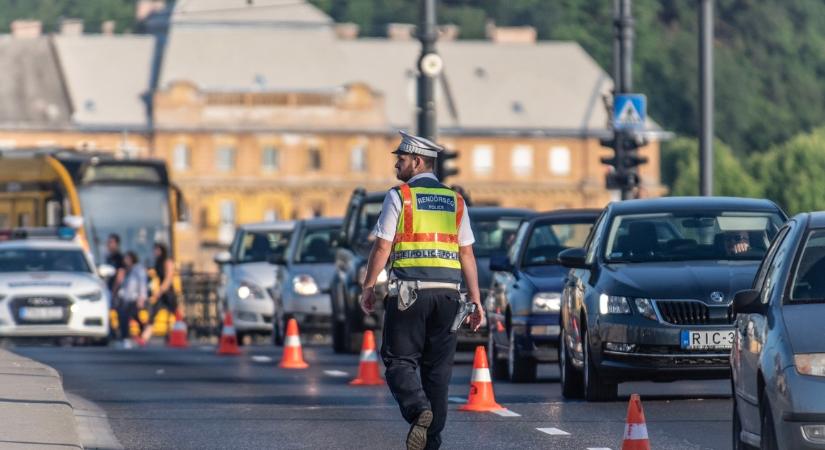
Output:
top-left (559, 197), bottom-right (786, 401)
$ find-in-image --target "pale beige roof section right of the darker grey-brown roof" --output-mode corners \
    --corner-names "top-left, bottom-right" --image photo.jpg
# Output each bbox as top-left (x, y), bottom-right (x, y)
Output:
top-left (54, 35), bottom-right (155, 129)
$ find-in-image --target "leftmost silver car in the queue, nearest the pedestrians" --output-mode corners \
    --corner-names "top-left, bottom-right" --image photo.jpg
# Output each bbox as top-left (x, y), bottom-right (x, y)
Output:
top-left (215, 221), bottom-right (295, 342)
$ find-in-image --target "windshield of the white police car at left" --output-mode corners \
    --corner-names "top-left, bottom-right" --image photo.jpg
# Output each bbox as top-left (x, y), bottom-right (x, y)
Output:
top-left (0, 248), bottom-right (92, 273)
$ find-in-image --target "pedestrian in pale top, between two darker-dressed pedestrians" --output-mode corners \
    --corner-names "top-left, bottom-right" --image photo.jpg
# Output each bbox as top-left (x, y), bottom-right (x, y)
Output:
top-left (117, 251), bottom-right (148, 348)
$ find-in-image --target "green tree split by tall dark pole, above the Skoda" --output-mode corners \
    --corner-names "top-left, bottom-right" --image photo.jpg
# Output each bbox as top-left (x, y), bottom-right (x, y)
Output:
top-left (662, 137), bottom-right (763, 197)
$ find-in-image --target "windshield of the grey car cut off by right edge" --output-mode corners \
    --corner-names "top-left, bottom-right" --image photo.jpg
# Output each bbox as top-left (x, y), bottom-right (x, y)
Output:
top-left (791, 230), bottom-right (825, 302)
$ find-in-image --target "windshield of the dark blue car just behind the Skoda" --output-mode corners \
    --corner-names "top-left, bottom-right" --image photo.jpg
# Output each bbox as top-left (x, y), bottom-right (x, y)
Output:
top-left (521, 220), bottom-right (593, 267)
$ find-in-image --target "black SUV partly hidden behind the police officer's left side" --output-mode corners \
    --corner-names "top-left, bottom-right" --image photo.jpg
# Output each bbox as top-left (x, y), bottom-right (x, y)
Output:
top-left (330, 189), bottom-right (387, 353)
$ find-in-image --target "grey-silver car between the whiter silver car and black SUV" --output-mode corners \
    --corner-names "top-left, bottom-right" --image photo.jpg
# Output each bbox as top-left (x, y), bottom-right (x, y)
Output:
top-left (272, 218), bottom-right (343, 345)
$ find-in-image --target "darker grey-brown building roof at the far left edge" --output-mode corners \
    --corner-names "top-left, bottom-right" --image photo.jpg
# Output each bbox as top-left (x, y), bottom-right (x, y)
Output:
top-left (0, 35), bottom-right (71, 128)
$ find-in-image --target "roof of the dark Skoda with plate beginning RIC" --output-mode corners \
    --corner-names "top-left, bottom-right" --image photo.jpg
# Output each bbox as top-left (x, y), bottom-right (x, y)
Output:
top-left (608, 197), bottom-right (784, 216)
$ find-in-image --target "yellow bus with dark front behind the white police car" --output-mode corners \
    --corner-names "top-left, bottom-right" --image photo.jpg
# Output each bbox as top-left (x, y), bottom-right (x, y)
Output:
top-left (0, 149), bottom-right (184, 334)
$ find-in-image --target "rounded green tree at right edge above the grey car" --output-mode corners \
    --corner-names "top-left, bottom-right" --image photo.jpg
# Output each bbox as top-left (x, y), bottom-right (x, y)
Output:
top-left (753, 128), bottom-right (825, 215)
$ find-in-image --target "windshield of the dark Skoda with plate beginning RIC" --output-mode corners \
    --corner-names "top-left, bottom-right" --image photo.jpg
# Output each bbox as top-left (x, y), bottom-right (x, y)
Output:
top-left (604, 211), bottom-right (782, 262)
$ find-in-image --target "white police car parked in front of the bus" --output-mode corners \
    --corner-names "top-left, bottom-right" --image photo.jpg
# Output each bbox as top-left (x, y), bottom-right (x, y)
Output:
top-left (0, 230), bottom-right (113, 343)
